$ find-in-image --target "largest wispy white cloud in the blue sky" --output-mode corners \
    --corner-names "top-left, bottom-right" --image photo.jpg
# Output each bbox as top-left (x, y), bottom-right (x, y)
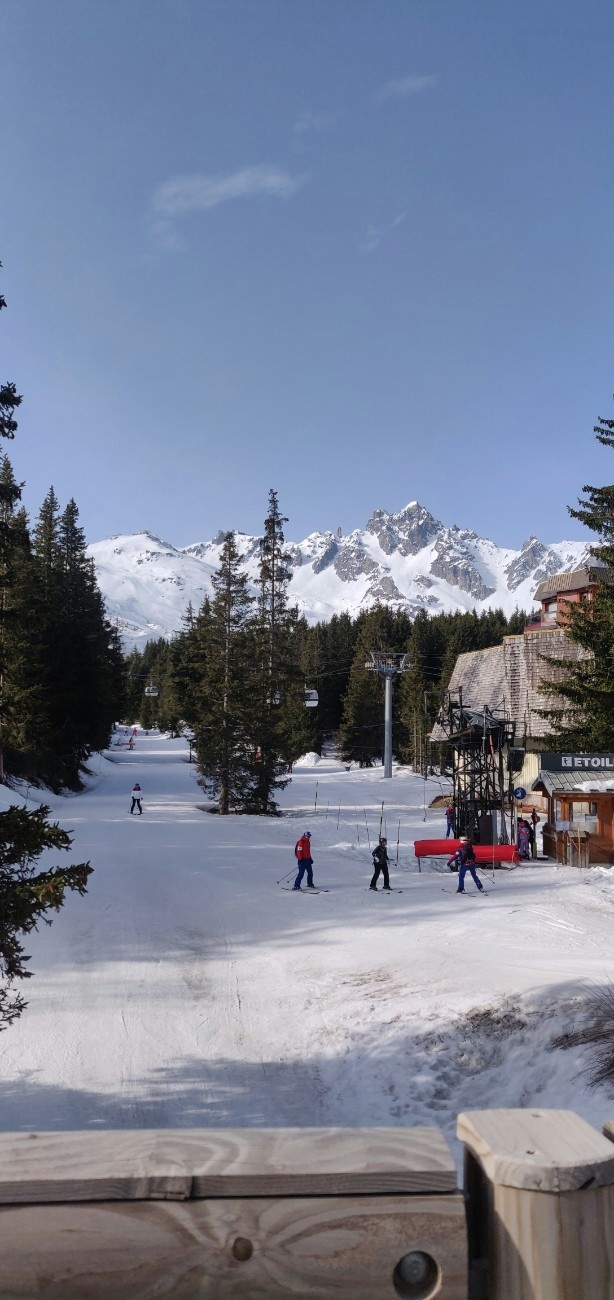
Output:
top-left (150, 163), bottom-right (304, 250)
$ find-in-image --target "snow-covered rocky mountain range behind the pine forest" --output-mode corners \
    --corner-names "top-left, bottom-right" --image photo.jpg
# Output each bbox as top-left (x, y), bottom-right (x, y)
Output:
top-left (88, 501), bottom-right (587, 650)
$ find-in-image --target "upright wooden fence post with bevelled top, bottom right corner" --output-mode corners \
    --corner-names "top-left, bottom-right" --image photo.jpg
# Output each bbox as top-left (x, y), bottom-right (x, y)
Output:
top-left (457, 1109), bottom-right (614, 1300)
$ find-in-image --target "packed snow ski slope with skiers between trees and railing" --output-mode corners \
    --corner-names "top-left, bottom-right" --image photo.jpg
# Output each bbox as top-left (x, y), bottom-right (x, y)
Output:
top-left (0, 732), bottom-right (614, 1180)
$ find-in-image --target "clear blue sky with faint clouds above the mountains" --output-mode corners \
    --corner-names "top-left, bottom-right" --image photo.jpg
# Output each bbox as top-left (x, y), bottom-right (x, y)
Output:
top-left (0, 0), bottom-right (614, 546)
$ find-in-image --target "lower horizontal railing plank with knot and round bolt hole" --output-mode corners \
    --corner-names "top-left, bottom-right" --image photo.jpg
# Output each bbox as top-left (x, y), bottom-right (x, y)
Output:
top-left (0, 1196), bottom-right (465, 1300)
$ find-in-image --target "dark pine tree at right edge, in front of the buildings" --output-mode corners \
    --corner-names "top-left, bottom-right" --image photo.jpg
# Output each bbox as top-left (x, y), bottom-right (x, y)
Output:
top-left (542, 408), bottom-right (614, 753)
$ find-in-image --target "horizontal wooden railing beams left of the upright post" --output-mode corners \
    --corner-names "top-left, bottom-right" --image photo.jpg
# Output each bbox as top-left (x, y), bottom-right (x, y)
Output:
top-left (0, 1128), bottom-right (468, 1300)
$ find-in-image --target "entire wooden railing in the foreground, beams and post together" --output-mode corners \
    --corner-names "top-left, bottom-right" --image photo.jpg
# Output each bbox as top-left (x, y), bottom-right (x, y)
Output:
top-left (0, 1109), bottom-right (614, 1300)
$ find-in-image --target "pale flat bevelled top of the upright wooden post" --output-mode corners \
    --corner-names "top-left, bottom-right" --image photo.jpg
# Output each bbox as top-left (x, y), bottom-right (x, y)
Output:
top-left (457, 1109), bottom-right (614, 1192)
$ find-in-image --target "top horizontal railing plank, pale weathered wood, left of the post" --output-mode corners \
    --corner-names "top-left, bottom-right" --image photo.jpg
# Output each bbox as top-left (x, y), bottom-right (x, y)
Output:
top-left (0, 1128), bottom-right (457, 1204)
